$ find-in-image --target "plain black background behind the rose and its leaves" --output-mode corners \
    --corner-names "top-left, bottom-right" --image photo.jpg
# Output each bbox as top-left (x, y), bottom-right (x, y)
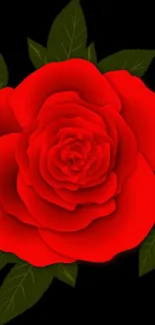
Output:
top-left (0, 0), bottom-right (155, 325)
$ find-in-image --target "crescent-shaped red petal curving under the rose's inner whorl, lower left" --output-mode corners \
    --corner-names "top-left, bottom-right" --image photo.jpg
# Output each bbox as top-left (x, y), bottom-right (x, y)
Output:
top-left (17, 175), bottom-right (115, 232)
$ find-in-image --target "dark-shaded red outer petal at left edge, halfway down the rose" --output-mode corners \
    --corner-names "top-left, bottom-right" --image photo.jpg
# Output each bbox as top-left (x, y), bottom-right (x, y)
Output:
top-left (0, 133), bottom-right (39, 226)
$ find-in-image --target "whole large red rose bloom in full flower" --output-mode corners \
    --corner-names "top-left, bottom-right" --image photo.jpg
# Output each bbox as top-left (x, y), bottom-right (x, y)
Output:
top-left (0, 59), bottom-right (155, 266)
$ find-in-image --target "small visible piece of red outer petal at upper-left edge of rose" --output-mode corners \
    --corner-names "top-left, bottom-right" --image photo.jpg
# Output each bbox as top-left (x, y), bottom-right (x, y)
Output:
top-left (0, 87), bottom-right (21, 136)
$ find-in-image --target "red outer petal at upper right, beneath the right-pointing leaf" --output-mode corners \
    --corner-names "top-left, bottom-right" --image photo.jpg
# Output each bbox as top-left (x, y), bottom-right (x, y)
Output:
top-left (104, 71), bottom-right (155, 170)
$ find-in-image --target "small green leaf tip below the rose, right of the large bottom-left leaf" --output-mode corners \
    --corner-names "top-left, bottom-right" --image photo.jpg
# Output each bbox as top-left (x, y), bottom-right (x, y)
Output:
top-left (55, 263), bottom-right (78, 287)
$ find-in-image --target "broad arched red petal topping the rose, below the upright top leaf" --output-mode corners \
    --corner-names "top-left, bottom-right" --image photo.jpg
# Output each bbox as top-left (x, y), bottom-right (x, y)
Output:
top-left (11, 59), bottom-right (121, 126)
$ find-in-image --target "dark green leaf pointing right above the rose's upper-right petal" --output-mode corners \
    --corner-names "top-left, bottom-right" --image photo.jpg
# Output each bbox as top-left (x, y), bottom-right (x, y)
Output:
top-left (98, 50), bottom-right (155, 77)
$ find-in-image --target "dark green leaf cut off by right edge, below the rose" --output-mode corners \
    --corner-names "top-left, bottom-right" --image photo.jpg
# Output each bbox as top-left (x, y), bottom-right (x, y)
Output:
top-left (139, 229), bottom-right (155, 276)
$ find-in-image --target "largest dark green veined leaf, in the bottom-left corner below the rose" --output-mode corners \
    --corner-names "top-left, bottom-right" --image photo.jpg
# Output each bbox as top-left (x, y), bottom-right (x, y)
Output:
top-left (0, 263), bottom-right (54, 325)
